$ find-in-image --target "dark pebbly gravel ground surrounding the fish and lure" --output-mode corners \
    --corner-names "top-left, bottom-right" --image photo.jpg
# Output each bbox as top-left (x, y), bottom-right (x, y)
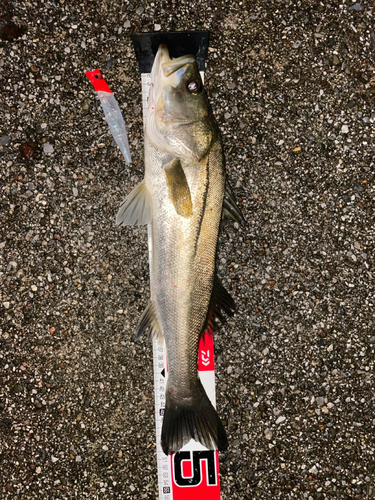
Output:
top-left (0, 0), bottom-right (375, 500)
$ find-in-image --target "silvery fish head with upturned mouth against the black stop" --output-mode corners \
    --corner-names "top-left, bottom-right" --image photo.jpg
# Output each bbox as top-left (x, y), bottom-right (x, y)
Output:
top-left (146, 45), bottom-right (218, 163)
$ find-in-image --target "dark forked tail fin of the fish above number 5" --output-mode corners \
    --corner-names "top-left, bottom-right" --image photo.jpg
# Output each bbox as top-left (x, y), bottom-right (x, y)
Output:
top-left (161, 379), bottom-right (228, 455)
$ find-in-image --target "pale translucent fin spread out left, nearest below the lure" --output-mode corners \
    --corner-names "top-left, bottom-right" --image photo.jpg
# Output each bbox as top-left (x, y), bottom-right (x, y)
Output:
top-left (116, 179), bottom-right (152, 226)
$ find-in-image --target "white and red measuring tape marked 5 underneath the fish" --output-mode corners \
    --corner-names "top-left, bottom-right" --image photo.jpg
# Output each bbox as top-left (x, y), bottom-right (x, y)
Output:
top-left (133, 33), bottom-right (220, 500)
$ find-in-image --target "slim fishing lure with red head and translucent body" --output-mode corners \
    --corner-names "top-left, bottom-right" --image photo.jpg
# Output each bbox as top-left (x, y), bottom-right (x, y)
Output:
top-left (85, 69), bottom-right (132, 163)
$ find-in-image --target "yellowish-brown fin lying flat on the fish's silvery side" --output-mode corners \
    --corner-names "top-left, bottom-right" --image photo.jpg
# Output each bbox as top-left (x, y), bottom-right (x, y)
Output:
top-left (164, 159), bottom-right (193, 217)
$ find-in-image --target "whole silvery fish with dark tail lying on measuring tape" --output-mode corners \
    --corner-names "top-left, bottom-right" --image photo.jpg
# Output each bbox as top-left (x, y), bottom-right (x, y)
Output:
top-left (116, 44), bottom-right (242, 455)
